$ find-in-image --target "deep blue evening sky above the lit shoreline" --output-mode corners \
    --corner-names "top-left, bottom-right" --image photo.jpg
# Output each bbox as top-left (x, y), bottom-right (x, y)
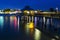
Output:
top-left (0, 0), bottom-right (60, 10)
